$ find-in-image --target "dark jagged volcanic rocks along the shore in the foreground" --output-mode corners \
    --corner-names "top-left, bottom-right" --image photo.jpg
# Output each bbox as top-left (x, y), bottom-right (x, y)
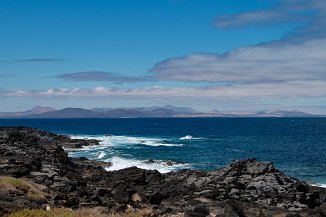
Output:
top-left (0, 127), bottom-right (326, 217)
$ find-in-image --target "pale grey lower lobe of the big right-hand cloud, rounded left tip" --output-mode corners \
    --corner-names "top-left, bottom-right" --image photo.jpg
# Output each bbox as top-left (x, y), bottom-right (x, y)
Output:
top-left (151, 39), bottom-right (326, 82)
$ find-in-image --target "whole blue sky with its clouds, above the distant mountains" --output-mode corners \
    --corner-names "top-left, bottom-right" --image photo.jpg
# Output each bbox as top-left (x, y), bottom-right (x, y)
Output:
top-left (0, 0), bottom-right (326, 114)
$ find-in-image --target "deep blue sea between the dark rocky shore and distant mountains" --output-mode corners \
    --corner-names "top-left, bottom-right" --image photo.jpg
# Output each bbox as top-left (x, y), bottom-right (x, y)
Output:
top-left (0, 118), bottom-right (326, 184)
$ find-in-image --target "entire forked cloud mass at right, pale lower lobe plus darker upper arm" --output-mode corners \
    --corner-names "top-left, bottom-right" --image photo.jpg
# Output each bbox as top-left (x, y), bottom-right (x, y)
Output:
top-left (150, 0), bottom-right (326, 85)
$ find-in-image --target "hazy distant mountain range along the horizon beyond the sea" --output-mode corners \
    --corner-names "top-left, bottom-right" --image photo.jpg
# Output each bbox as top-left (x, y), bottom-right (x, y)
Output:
top-left (0, 105), bottom-right (321, 118)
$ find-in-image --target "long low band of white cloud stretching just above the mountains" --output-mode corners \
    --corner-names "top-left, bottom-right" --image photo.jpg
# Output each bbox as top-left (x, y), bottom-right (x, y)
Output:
top-left (0, 81), bottom-right (326, 99)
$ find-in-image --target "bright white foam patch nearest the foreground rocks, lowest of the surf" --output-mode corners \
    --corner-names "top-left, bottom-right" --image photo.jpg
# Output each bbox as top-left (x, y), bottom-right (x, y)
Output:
top-left (105, 157), bottom-right (189, 173)
